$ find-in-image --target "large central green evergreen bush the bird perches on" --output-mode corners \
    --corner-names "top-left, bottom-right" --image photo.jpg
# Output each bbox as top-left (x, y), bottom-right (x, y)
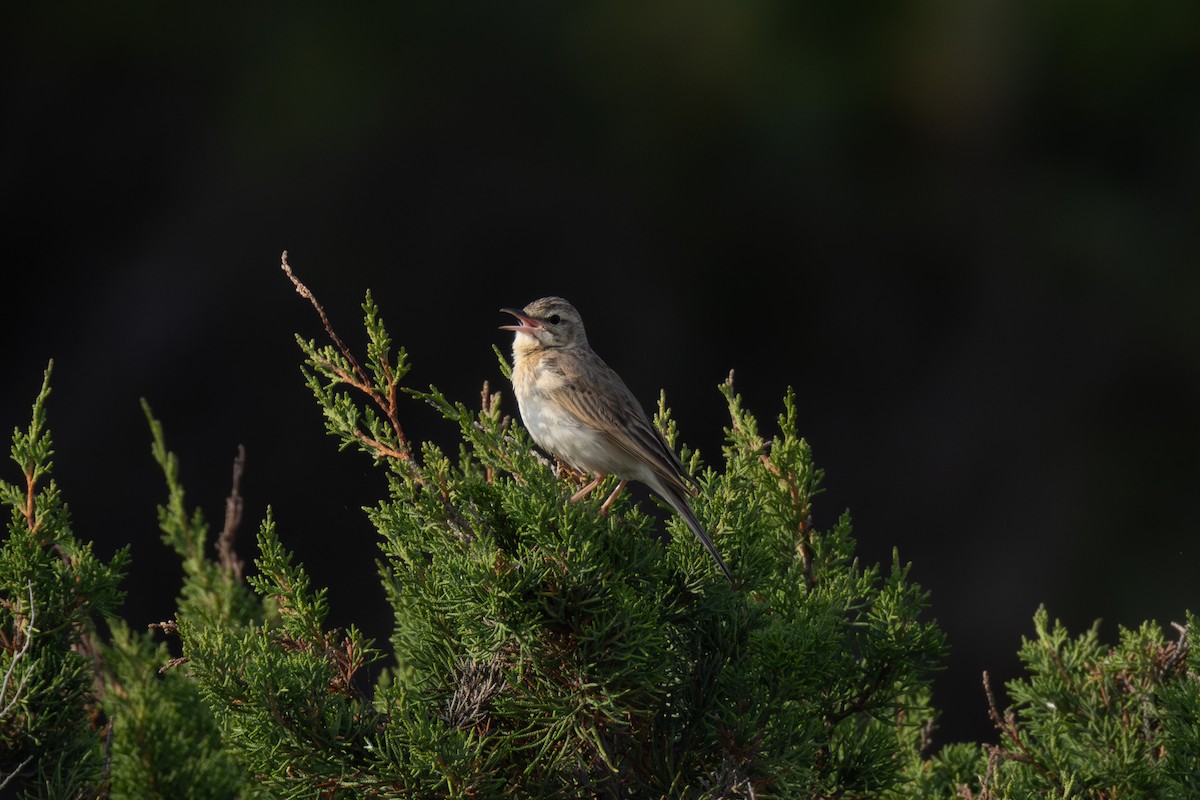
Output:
top-left (280, 280), bottom-right (944, 798)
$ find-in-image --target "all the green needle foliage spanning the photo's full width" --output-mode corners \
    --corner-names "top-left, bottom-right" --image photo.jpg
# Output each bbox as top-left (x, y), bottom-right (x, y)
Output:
top-left (0, 271), bottom-right (1200, 800)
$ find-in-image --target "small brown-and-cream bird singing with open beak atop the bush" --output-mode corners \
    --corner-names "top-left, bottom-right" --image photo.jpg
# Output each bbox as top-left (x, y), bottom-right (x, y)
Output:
top-left (500, 296), bottom-right (733, 583)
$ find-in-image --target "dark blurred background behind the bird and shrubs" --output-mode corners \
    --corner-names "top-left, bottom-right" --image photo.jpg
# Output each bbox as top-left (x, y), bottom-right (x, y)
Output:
top-left (0, 0), bottom-right (1200, 741)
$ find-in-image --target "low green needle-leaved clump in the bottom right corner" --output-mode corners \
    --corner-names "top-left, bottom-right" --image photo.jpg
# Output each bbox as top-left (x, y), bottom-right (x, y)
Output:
top-left (974, 609), bottom-right (1200, 798)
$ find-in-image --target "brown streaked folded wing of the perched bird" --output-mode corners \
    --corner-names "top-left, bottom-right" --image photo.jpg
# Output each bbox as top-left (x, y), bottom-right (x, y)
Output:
top-left (554, 351), bottom-right (692, 494)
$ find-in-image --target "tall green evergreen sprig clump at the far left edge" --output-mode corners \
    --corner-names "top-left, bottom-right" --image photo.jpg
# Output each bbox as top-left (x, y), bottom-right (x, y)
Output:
top-left (0, 365), bottom-right (128, 798)
